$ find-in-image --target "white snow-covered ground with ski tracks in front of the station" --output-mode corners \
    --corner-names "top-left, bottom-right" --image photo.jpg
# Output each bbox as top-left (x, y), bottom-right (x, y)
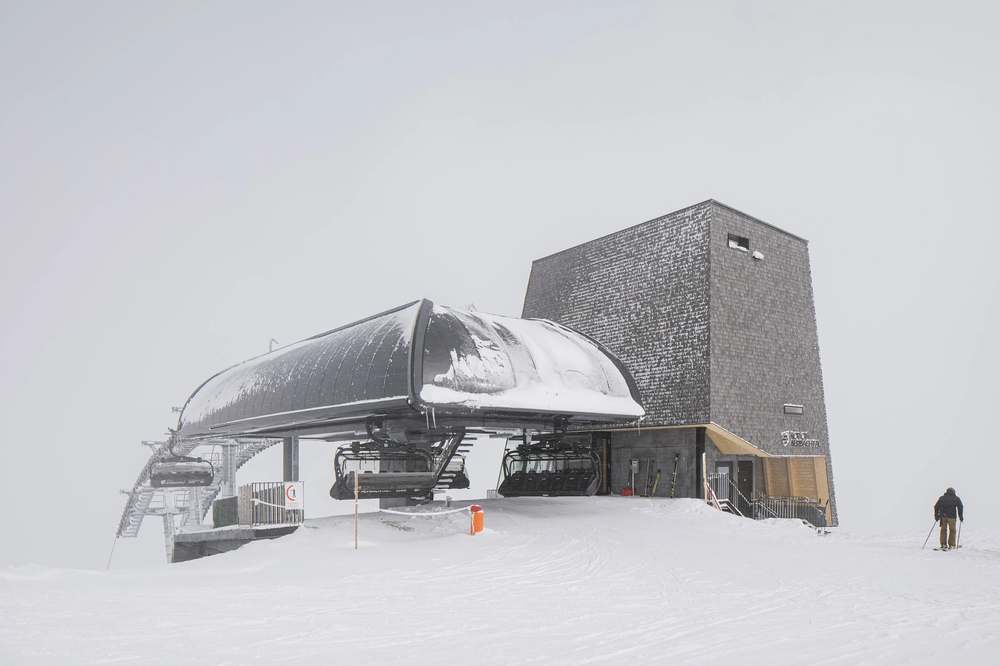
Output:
top-left (0, 498), bottom-right (1000, 665)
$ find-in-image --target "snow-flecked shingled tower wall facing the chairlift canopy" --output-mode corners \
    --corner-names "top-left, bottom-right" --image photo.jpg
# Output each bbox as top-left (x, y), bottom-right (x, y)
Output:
top-left (522, 202), bottom-right (711, 426)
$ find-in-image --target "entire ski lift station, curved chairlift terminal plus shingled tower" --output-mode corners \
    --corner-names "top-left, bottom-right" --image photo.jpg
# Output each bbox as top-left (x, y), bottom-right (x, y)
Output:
top-left (118, 200), bottom-right (837, 561)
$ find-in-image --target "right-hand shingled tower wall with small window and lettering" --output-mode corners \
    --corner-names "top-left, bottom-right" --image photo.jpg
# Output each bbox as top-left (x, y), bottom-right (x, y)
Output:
top-left (709, 202), bottom-right (836, 524)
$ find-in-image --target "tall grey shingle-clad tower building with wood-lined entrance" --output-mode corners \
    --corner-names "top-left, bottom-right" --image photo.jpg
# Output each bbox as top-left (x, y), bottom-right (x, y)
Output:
top-left (522, 200), bottom-right (837, 526)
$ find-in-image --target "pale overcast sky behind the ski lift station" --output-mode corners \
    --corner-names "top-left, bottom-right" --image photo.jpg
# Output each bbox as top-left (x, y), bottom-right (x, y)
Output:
top-left (0, 0), bottom-right (1000, 568)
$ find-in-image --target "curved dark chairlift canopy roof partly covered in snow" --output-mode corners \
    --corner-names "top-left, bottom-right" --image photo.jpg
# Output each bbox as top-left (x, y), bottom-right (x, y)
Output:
top-left (178, 300), bottom-right (644, 437)
